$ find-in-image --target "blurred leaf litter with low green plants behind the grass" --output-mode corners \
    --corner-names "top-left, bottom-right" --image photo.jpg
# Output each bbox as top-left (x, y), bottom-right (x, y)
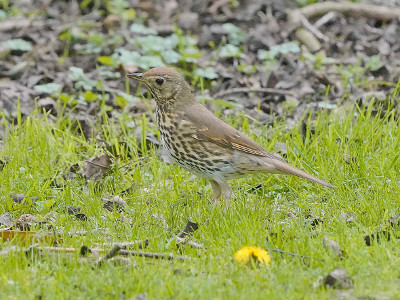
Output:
top-left (0, 0), bottom-right (400, 132)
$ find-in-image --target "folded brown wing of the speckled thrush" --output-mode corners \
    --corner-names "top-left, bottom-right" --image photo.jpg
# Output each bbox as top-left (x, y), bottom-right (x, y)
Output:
top-left (184, 103), bottom-right (284, 161)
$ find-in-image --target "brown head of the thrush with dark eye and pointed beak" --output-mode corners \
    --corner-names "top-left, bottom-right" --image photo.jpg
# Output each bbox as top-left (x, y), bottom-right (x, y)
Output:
top-left (126, 67), bottom-right (190, 104)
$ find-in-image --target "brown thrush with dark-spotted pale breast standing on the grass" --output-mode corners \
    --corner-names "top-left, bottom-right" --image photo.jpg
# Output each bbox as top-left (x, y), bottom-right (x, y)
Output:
top-left (126, 67), bottom-right (334, 212)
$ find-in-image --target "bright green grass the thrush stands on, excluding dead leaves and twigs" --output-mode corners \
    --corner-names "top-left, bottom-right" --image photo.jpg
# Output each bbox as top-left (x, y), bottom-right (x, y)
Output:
top-left (0, 104), bottom-right (400, 299)
